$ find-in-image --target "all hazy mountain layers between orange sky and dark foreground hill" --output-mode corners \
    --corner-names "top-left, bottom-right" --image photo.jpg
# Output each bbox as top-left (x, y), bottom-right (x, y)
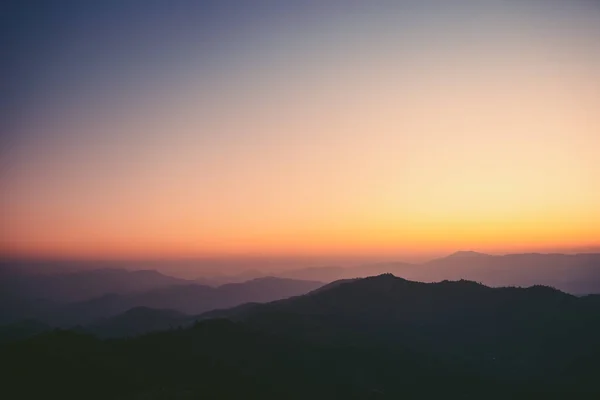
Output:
top-left (0, 251), bottom-right (600, 327)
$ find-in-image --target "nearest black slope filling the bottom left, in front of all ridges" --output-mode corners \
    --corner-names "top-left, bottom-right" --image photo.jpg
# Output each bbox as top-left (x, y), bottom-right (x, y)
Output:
top-left (0, 320), bottom-right (540, 399)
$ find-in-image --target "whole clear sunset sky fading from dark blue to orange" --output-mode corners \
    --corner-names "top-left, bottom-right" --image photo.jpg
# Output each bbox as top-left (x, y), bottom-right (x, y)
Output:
top-left (0, 0), bottom-right (600, 258)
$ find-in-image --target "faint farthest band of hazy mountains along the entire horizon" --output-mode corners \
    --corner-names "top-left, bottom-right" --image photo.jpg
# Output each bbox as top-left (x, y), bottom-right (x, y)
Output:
top-left (0, 251), bottom-right (600, 292)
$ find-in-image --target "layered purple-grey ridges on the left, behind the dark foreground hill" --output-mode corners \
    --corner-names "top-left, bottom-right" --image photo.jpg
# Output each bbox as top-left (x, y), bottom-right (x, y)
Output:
top-left (0, 269), bottom-right (323, 329)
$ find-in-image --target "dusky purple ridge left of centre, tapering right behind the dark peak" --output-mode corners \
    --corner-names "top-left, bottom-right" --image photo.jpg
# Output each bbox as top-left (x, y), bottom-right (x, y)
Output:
top-left (50, 277), bottom-right (323, 326)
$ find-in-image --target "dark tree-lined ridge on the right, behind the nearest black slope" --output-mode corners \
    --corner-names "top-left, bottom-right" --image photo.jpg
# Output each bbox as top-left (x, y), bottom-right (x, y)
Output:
top-left (203, 274), bottom-right (600, 378)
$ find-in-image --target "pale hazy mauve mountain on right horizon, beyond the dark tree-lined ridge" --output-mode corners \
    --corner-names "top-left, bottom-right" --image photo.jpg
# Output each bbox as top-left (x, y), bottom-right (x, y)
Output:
top-left (277, 251), bottom-right (600, 295)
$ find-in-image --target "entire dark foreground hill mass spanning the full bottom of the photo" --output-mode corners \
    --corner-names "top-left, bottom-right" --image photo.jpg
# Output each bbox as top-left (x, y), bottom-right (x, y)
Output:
top-left (0, 275), bottom-right (600, 399)
